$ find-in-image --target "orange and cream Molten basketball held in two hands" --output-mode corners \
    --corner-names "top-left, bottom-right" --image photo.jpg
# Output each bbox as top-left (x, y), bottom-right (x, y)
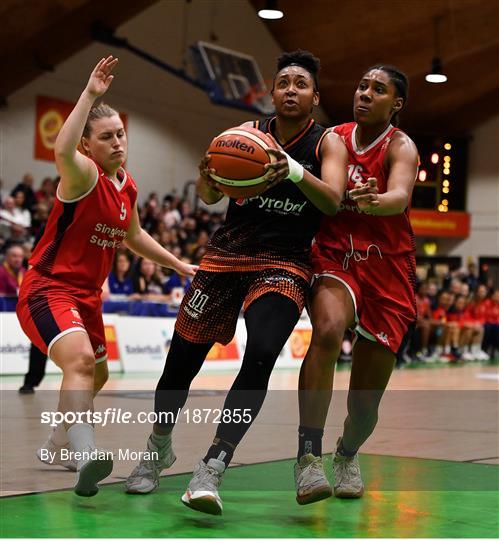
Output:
top-left (208, 127), bottom-right (276, 199)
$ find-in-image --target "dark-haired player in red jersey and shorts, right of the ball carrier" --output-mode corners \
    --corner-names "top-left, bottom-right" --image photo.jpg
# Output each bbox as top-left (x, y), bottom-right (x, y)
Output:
top-left (295, 65), bottom-right (418, 504)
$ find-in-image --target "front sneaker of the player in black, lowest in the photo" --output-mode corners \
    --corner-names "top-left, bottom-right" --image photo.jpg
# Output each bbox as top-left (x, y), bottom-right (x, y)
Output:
top-left (182, 458), bottom-right (225, 516)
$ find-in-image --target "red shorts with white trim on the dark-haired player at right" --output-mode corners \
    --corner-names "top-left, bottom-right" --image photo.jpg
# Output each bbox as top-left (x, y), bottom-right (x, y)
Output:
top-left (312, 245), bottom-right (416, 353)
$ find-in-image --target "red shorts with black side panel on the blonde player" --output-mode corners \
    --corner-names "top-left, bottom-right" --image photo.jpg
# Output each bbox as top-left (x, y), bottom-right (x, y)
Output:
top-left (16, 268), bottom-right (107, 363)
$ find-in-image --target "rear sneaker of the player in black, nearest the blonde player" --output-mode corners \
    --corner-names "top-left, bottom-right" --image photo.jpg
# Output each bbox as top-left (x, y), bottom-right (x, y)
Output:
top-left (125, 433), bottom-right (177, 494)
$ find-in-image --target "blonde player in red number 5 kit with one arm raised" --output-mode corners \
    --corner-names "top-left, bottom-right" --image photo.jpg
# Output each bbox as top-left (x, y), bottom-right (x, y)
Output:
top-left (17, 56), bottom-right (196, 496)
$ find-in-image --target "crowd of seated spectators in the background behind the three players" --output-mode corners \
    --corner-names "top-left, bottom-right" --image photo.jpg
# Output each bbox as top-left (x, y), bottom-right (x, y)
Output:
top-left (0, 174), bottom-right (499, 363)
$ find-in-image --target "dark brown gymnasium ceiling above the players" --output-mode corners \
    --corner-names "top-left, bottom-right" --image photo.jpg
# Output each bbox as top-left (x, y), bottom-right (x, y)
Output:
top-left (0, 0), bottom-right (499, 134)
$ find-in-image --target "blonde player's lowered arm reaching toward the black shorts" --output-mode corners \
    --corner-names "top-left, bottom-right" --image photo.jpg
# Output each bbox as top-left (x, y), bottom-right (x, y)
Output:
top-left (125, 203), bottom-right (198, 277)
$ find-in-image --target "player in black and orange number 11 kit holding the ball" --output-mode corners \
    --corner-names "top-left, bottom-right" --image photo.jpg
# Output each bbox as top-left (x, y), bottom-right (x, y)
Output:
top-left (126, 51), bottom-right (347, 514)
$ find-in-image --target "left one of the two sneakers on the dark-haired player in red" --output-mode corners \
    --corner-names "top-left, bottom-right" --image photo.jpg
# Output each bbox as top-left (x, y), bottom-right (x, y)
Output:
top-left (295, 454), bottom-right (333, 504)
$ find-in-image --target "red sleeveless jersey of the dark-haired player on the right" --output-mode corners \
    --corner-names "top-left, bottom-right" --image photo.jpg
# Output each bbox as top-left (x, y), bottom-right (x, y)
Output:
top-left (316, 122), bottom-right (415, 255)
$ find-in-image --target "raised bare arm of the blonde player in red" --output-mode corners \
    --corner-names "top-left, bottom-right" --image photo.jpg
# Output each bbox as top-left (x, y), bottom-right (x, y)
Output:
top-left (54, 56), bottom-right (118, 199)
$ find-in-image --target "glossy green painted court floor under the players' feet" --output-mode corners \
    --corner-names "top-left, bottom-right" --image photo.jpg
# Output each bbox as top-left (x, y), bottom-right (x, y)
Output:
top-left (0, 455), bottom-right (499, 538)
